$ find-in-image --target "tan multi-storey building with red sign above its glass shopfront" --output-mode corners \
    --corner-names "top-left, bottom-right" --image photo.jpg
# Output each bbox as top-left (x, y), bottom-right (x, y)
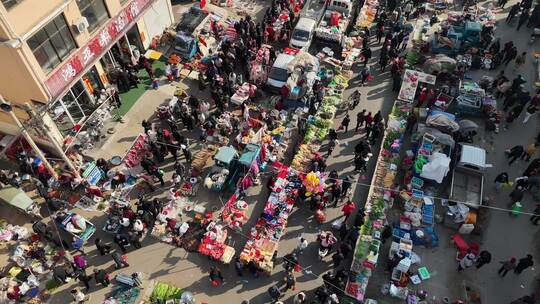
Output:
top-left (0, 0), bottom-right (174, 145)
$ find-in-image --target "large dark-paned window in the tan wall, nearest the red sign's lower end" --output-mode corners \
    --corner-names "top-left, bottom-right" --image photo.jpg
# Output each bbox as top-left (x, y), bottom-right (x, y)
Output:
top-left (28, 15), bottom-right (76, 73)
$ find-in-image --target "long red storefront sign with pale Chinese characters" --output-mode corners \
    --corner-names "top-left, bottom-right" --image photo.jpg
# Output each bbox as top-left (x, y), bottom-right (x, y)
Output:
top-left (45, 0), bottom-right (154, 98)
